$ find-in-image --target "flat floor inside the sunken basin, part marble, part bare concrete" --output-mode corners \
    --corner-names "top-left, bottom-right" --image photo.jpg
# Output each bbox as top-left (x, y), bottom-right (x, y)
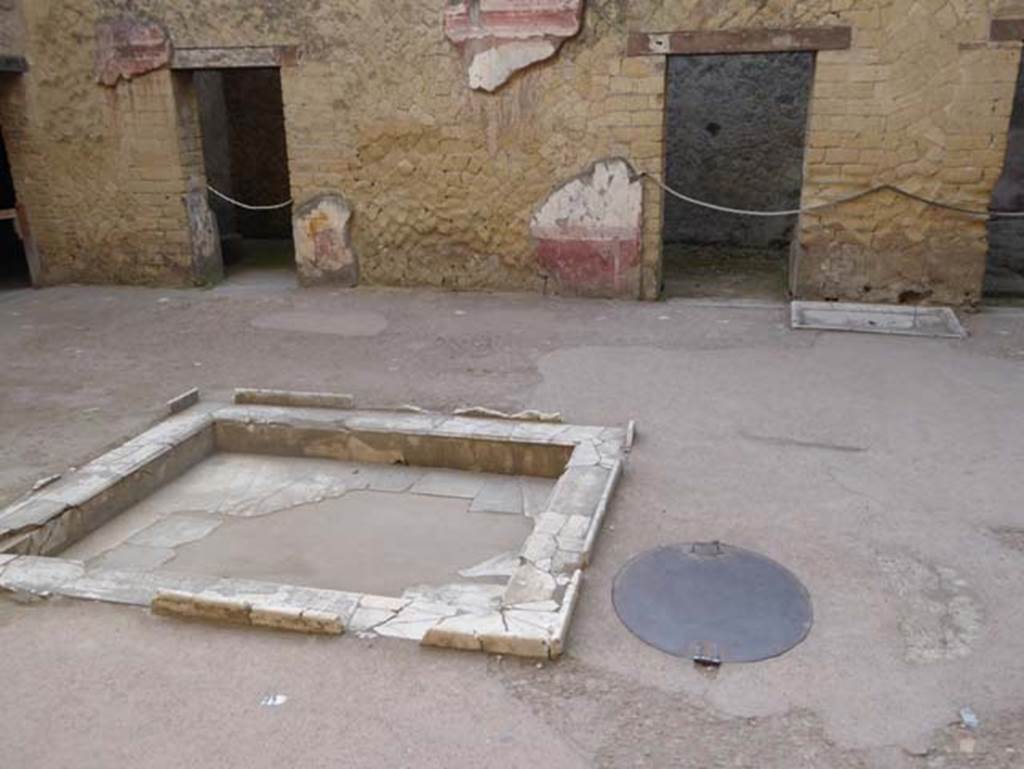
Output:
top-left (60, 453), bottom-right (555, 596)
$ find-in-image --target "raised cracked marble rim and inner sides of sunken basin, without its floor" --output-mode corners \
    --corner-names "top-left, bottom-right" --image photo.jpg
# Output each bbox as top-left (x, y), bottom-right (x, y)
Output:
top-left (0, 391), bottom-right (633, 658)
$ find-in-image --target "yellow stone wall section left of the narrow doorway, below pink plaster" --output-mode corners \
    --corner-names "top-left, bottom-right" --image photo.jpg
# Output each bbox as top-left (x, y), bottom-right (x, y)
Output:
top-left (0, 1), bottom-right (201, 285)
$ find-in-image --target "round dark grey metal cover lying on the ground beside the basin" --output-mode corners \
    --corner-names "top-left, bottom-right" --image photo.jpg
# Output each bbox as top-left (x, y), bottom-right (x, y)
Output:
top-left (611, 542), bottom-right (813, 664)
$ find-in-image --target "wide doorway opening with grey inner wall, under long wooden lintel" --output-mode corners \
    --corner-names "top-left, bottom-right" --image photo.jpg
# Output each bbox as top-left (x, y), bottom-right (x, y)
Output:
top-left (663, 52), bottom-right (814, 299)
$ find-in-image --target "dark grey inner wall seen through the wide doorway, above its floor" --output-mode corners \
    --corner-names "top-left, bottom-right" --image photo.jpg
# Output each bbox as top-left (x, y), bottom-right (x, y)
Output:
top-left (665, 52), bottom-right (814, 248)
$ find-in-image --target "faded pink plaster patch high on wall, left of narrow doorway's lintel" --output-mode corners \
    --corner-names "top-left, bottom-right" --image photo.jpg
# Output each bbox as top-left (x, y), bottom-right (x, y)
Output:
top-left (95, 16), bottom-right (172, 85)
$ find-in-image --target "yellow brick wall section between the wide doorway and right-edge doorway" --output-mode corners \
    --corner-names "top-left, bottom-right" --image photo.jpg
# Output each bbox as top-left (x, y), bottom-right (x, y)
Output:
top-left (795, 5), bottom-right (1020, 304)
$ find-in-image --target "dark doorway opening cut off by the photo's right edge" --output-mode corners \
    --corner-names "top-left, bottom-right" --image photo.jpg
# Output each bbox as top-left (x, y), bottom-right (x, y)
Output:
top-left (983, 51), bottom-right (1024, 302)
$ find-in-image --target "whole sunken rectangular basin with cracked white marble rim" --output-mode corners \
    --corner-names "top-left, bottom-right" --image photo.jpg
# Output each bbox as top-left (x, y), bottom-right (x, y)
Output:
top-left (0, 397), bottom-right (632, 657)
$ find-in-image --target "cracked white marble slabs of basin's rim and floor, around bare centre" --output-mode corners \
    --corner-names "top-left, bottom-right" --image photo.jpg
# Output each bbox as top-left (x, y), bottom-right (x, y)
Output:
top-left (0, 405), bottom-right (626, 657)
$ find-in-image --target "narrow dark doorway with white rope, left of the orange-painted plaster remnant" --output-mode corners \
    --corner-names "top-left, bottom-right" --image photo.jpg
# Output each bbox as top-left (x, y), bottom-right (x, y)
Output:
top-left (194, 68), bottom-right (295, 275)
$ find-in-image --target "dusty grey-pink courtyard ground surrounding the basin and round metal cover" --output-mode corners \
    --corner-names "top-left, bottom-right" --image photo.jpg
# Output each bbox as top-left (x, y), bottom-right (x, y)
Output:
top-left (0, 275), bottom-right (1024, 769)
